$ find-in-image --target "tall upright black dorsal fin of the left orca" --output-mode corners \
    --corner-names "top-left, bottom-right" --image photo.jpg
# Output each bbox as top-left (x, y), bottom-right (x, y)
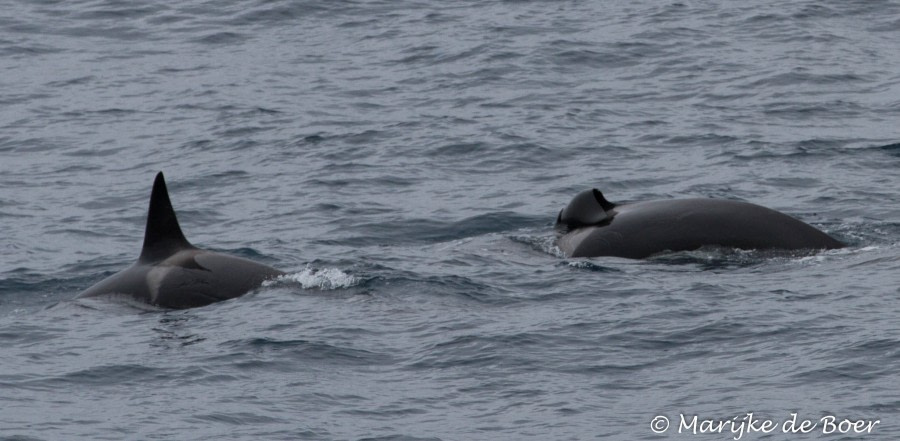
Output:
top-left (140, 172), bottom-right (193, 262)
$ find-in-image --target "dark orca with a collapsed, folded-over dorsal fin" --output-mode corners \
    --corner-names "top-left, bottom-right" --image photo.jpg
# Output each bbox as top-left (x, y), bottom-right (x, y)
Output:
top-left (556, 188), bottom-right (845, 259)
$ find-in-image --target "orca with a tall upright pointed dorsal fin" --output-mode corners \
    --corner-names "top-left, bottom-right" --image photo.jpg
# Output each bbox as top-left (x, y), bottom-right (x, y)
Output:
top-left (76, 172), bottom-right (284, 309)
